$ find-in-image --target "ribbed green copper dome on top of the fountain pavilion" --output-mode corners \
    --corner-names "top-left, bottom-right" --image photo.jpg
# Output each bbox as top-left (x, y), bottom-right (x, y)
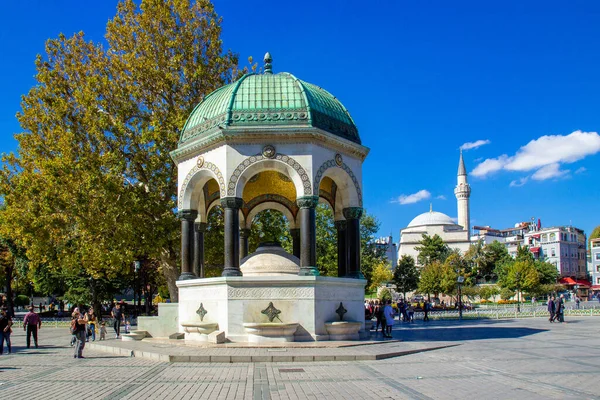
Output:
top-left (179, 69), bottom-right (360, 146)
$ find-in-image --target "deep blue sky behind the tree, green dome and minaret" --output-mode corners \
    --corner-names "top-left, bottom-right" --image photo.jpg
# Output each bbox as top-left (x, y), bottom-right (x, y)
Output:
top-left (0, 0), bottom-right (600, 240)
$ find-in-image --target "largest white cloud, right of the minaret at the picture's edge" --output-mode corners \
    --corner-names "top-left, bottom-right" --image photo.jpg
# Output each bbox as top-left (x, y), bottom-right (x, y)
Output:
top-left (471, 131), bottom-right (600, 180)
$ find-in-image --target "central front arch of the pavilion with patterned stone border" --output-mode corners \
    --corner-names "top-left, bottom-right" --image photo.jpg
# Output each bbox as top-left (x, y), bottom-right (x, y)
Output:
top-left (227, 153), bottom-right (313, 198)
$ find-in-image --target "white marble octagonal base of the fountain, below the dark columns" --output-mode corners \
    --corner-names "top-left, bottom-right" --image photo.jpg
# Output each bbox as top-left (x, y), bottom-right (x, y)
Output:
top-left (177, 275), bottom-right (367, 342)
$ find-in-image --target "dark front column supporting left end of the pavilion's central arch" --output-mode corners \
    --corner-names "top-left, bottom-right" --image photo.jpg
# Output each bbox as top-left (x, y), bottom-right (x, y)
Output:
top-left (221, 197), bottom-right (244, 276)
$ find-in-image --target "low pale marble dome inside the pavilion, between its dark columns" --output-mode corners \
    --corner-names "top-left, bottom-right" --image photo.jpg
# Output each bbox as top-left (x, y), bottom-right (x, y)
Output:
top-left (240, 243), bottom-right (300, 276)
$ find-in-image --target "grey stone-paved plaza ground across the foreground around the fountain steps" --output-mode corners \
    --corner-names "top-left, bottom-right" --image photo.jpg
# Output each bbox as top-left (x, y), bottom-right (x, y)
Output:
top-left (0, 317), bottom-right (600, 400)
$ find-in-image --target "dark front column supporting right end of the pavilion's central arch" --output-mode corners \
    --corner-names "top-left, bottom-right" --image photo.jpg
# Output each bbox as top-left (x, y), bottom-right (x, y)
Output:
top-left (296, 196), bottom-right (319, 276)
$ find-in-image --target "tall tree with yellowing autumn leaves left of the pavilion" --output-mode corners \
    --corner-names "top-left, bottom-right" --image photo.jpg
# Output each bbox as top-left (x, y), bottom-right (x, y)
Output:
top-left (0, 0), bottom-right (238, 301)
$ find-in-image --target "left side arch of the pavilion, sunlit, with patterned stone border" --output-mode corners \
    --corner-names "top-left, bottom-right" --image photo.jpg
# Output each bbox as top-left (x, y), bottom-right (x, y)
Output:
top-left (177, 162), bottom-right (225, 222)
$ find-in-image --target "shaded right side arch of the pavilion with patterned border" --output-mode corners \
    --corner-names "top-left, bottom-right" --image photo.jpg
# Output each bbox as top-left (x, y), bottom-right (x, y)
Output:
top-left (313, 159), bottom-right (363, 211)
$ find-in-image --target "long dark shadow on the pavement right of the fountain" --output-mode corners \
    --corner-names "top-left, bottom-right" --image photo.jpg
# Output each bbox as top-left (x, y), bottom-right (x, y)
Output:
top-left (392, 326), bottom-right (547, 342)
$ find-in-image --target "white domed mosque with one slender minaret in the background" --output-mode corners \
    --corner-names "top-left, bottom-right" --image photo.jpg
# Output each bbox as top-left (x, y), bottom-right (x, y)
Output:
top-left (398, 151), bottom-right (471, 265)
